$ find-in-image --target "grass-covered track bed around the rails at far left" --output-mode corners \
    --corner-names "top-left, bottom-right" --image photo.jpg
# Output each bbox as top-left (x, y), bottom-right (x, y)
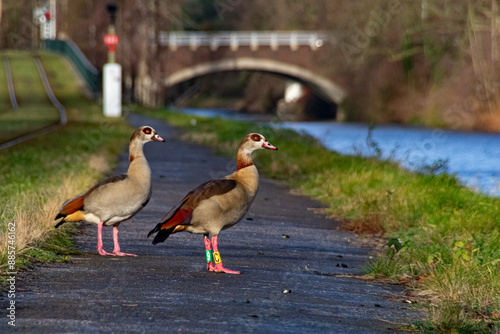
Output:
top-left (0, 51), bottom-right (61, 142)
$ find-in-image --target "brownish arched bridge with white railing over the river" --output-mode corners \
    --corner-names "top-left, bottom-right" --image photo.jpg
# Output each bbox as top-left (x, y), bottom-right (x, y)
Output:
top-left (139, 31), bottom-right (346, 116)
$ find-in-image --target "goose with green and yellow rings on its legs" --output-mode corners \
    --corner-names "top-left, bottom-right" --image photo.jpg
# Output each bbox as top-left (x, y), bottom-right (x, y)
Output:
top-left (148, 133), bottom-right (277, 274)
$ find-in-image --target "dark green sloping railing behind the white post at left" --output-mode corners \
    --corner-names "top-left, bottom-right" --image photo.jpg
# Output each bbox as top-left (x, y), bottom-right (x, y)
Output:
top-left (43, 39), bottom-right (101, 94)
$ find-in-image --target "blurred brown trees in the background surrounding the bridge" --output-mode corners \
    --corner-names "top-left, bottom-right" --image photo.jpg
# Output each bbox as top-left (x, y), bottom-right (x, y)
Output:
top-left (0, 0), bottom-right (500, 130)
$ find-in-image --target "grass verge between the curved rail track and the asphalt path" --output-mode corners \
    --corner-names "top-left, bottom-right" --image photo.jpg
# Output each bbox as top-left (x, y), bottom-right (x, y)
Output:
top-left (0, 54), bottom-right (131, 280)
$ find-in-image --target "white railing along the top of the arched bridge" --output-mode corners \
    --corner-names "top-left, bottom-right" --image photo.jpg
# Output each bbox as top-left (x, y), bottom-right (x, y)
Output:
top-left (158, 31), bottom-right (328, 50)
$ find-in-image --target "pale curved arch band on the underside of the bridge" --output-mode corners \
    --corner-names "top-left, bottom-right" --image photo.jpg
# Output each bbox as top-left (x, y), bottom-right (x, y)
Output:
top-left (164, 58), bottom-right (346, 105)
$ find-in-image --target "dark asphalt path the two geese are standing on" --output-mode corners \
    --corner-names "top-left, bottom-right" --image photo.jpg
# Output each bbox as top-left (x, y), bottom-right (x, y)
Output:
top-left (4, 115), bottom-right (424, 333)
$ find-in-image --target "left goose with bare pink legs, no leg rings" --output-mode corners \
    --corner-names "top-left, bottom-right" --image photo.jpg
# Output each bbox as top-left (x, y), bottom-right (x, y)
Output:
top-left (55, 126), bottom-right (165, 256)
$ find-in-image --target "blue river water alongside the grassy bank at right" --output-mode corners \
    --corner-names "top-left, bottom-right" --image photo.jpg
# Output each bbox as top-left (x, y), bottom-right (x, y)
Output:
top-left (177, 109), bottom-right (500, 196)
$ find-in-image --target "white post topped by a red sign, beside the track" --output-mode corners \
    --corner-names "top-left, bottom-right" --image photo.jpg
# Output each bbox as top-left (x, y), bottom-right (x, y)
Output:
top-left (102, 3), bottom-right (122, 117)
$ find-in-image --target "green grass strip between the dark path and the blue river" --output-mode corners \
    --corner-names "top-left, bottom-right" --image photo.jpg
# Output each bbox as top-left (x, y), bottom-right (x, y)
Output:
top-left (135, 107), bottom-right (500, 332)
